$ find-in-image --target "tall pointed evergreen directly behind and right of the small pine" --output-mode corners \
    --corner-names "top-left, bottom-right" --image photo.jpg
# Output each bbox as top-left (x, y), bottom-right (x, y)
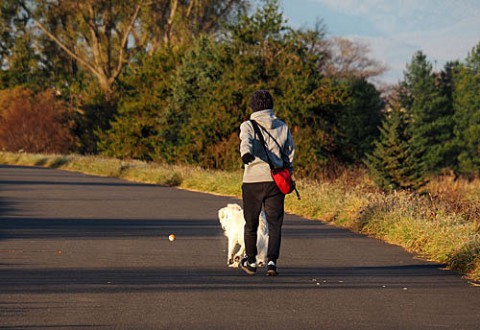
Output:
top-left (400, 52), bottom-right (455, 175)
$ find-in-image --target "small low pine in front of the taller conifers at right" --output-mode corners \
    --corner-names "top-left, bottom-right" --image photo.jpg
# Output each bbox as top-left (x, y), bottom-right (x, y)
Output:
top-left (365, 108), bottom-right (425, 190)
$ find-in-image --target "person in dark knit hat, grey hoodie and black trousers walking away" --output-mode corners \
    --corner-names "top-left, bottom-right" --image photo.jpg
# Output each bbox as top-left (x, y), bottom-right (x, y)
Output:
top-left (239, 90), bottom-right (295, 276)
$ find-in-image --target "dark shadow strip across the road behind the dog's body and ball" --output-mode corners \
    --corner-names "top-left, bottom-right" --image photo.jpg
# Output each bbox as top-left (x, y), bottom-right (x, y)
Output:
top-left (0, 213), bottom-right (356, 239)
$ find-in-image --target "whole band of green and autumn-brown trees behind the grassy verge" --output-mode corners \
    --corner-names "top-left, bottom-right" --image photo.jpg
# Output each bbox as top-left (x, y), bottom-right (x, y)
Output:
top-left (0, 0), bottom-right (480, 189)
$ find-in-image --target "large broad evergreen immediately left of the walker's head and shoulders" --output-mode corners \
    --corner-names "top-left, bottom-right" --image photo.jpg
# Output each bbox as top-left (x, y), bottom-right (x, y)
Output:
top-left (168, 36), bottom-right (242, 168)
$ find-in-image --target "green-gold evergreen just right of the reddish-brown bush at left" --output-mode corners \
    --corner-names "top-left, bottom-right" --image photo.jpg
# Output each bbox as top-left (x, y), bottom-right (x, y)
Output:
top-left (99, 51), bottom-right (181, 162)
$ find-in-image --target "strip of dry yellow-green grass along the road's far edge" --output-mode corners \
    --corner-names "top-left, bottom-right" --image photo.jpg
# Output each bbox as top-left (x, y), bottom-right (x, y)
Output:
top-left (0, 152), bottom-right (480, 281)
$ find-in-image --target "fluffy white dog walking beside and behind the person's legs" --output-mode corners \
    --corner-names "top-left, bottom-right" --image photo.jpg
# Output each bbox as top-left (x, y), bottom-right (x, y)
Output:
top-left (218, 204), bottom-right (268, 267)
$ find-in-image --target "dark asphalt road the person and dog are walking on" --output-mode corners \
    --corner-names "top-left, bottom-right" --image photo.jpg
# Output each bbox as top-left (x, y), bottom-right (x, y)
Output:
top-left (0, 166), bottom-right (480, 329)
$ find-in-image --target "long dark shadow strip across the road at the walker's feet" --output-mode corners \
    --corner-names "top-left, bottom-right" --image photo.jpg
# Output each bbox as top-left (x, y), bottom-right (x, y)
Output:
top-left (0, 264), bottom-right (458, 294)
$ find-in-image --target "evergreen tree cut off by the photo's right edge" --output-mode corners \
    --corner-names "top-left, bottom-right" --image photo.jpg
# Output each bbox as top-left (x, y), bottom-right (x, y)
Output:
top-left (453, 43), bottom-right (480, 175)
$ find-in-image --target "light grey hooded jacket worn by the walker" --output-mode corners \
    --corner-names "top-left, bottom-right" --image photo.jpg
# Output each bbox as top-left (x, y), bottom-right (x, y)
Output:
top-left (240, 109), bottom-right (295, 183)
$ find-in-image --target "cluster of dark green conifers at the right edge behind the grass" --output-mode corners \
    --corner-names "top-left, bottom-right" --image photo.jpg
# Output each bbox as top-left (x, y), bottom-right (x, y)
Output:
top-left (366, 47), bottom-right (480, 190)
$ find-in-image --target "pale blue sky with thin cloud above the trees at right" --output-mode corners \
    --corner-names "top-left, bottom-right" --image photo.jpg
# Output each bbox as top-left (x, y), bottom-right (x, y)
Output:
top-left (280, 0), bottom-right (480, 83)
